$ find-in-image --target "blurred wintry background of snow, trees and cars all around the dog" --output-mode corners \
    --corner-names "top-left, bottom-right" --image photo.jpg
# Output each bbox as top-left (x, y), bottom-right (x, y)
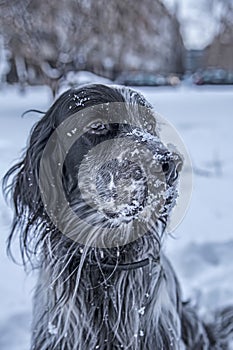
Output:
top-left (0, 0), bottom-right (233, 350)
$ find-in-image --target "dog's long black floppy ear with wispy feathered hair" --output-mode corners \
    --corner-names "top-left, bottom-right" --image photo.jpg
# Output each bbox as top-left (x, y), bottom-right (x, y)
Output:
top-left (3, 91), bottom-right (72, 263)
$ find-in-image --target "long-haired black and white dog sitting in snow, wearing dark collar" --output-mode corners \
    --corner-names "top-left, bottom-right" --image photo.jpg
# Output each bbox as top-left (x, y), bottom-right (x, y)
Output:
top-left (4, 84), bottom-right (233, 350)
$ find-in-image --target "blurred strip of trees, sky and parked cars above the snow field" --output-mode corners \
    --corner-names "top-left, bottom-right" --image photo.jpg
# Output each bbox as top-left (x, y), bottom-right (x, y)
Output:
top-left (0, 0), bottom-right (233, 94)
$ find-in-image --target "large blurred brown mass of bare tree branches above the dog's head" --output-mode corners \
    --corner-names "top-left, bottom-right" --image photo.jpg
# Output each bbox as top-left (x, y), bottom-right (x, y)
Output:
top-left (0, 0), bottom-right (186, 89)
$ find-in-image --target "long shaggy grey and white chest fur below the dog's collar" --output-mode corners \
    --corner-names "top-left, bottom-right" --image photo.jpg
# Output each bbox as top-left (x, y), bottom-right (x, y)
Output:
top-left (34, 255), bottom-right (182, 350)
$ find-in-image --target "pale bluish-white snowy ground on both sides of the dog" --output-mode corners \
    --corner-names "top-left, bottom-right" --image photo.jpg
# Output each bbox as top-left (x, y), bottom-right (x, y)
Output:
top-left (0, 86), bottom-right (233, 350)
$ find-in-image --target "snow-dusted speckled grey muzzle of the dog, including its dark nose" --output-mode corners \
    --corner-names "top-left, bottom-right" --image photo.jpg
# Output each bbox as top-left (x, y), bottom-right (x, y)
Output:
top-left (79, 131), bottom-right (182, 222)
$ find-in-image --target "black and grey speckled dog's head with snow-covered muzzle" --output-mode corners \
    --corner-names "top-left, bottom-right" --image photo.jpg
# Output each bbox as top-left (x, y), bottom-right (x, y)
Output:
top-left (5, 85), bottom-right (182, 262)
